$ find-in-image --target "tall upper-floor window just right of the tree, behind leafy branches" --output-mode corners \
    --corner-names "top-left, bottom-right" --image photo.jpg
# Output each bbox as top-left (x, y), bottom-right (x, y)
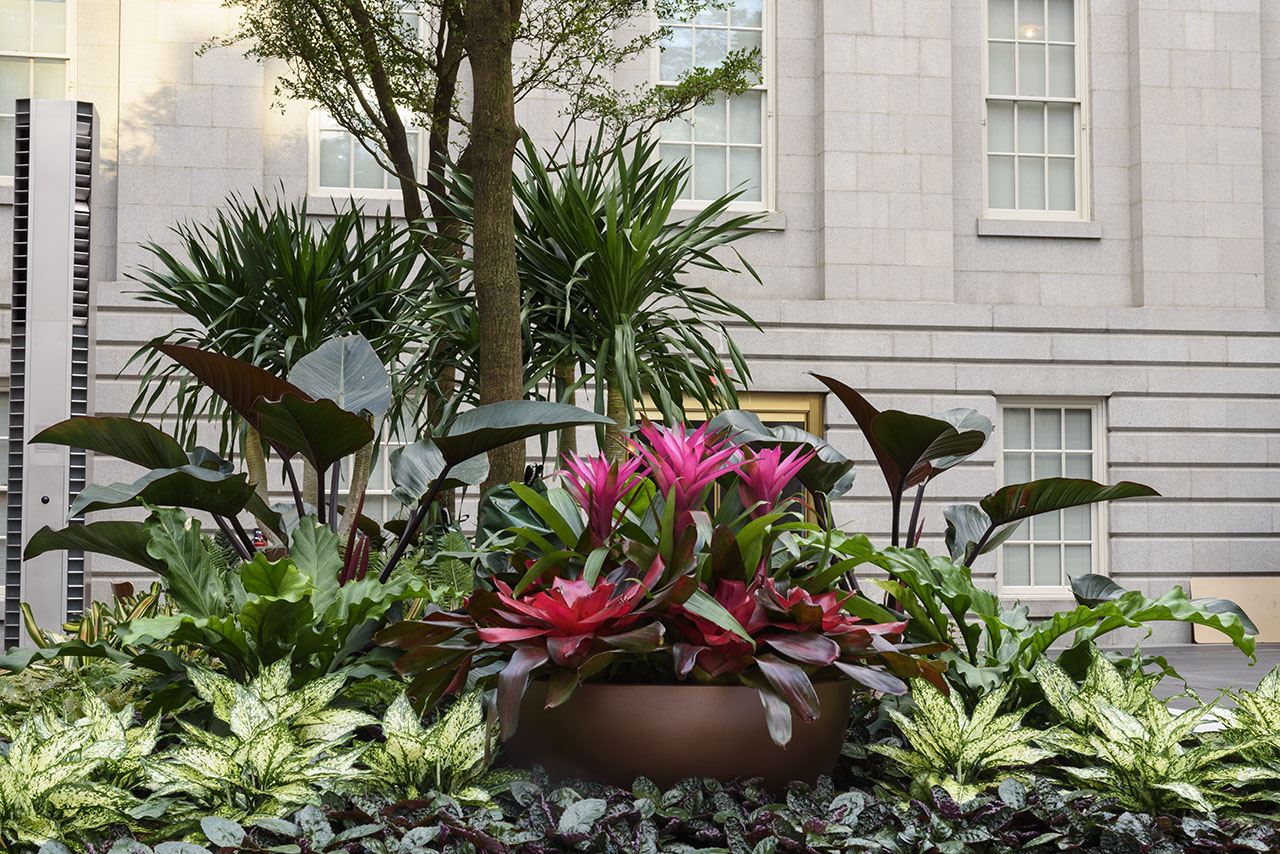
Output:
top-left (655, 0), bottom-right (773, 207)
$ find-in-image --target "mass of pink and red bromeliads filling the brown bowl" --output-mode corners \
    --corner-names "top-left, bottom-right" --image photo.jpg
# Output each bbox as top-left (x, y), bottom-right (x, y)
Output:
top-left (379, 424), bottom-right (946, 745)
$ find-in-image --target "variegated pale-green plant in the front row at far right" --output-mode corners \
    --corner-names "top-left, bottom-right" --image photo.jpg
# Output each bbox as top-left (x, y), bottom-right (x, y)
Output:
top-left (1036, 650), bottom-right (1280, 814)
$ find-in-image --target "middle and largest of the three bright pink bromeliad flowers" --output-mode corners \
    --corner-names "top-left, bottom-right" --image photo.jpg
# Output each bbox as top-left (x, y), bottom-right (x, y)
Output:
top-left (640, 421), bottom-right (741, 533)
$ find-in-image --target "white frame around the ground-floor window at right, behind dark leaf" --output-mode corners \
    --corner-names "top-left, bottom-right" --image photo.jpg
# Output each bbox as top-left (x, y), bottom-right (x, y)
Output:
top-left (995, 396), bottom-right (1111, 600)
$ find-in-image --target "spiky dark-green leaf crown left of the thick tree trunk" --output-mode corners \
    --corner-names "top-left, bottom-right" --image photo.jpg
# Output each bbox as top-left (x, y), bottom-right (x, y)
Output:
top-left (129, 192), bottom-right (445, 456)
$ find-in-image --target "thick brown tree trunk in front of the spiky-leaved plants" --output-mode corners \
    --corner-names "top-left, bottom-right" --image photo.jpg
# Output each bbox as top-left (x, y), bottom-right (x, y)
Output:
top-left (466, 0), bottom-right (525, 489)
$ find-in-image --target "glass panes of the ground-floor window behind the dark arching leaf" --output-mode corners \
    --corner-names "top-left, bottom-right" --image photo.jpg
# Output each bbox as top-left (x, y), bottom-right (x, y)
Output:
top-left (1000, 402), bottom-right (1103, 595)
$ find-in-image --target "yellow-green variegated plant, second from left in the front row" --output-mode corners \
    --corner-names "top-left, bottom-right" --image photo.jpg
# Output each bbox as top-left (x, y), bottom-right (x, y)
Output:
top-left (147, 659), bottom-right (378, 826)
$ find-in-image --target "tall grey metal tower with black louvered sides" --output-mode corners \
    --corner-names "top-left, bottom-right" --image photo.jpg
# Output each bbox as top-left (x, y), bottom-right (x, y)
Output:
top-left (4, 100), bottom-right (96, 648)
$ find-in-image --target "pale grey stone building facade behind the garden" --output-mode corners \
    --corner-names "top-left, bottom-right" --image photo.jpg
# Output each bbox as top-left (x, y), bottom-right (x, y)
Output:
top-left (0, 0), bottom-right (1280, 640)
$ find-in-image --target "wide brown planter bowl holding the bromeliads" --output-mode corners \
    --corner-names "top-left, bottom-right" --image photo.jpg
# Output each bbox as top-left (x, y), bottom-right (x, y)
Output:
top-left (506, 680), bottom-right (852, 790)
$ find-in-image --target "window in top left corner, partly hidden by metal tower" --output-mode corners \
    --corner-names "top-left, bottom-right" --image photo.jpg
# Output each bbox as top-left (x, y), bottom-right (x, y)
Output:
top-left (0, 0), bottom-right (70, 178)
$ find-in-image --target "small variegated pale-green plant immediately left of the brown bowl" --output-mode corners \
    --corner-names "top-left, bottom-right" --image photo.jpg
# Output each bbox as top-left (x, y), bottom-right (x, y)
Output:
top-left (364, 691), bottom-right (526, 804)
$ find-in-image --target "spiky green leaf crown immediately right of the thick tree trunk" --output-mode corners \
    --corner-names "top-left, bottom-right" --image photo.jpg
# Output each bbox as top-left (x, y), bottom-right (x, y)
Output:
top-left (444, 134), bottom-right (762, 458)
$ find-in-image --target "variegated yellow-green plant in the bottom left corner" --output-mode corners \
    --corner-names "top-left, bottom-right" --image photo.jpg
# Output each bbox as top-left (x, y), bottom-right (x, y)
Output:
top-left (0, 697), bottom-right (144, 849)
